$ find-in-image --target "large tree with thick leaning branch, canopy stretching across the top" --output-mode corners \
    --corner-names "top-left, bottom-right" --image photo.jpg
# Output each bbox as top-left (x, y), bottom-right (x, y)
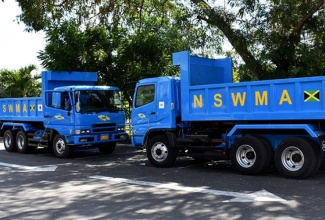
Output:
top-left (12, 0), bottom-right (325, 80)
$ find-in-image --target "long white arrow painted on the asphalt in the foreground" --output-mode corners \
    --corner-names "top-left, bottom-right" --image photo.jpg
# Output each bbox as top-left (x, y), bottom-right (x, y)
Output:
top-left (88, 176), bottom-right (286, 202)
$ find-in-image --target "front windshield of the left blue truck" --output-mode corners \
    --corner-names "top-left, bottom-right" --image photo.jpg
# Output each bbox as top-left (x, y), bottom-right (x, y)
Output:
top-left (75, 90), bottom-right (123, 113)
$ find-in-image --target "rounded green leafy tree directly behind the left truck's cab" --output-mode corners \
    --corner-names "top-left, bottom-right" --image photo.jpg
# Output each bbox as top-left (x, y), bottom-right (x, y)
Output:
top-left (38, 21), bottom-right (113, 72)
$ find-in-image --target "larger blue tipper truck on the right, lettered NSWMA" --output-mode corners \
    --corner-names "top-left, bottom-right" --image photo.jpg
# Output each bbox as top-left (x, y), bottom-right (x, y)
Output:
top-left (131, 51), bottom-right (325, 179)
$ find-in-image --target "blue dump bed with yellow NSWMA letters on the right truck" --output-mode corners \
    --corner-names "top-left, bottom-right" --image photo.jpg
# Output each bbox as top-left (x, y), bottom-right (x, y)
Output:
top-left (173, 51), bottom-right (325, 121)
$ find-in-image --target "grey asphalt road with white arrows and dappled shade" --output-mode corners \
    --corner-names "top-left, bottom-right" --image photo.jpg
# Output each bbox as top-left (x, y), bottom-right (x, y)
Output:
top-left (0, 143), bottom-right (325, 220)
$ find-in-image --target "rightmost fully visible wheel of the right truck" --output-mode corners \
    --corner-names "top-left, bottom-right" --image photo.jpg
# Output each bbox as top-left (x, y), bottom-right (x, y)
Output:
top-left (274, 137), bottom-right (318, 179)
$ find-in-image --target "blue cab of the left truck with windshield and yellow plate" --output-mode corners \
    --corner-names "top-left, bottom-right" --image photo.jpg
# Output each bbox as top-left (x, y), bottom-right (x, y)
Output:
top-left (43, 86), bottom-right (126, 158)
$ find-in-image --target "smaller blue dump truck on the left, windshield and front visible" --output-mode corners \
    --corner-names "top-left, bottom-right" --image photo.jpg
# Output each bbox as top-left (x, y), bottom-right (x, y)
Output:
top-left (0, 71), bottom-right (127, 158)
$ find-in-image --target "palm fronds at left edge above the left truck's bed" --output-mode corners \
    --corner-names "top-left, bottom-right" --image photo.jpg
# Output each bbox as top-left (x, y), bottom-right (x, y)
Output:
top-left (0, 65), bottom-right (41, 98)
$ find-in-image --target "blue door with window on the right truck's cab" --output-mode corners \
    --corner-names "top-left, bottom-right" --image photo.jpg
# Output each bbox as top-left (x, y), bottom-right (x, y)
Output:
top-left (131, 83), bottom-right (157, 146)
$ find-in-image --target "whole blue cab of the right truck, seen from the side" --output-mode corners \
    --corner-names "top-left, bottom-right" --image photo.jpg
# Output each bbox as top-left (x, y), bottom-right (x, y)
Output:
top-left (131, 77), bottom-right (180, 147)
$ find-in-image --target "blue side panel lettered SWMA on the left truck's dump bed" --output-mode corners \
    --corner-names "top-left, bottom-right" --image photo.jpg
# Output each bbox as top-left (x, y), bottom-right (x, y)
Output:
top-left (0, 97), bottom-right (44, 122)
